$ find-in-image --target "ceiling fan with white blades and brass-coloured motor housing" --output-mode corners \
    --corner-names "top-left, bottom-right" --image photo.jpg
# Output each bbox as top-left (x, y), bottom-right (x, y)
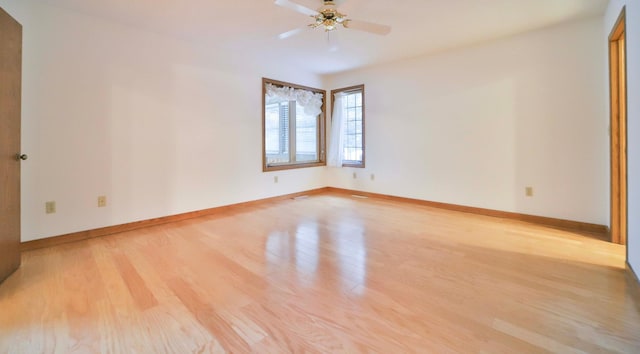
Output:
top-left (275, 0), bottom-right (391, 39)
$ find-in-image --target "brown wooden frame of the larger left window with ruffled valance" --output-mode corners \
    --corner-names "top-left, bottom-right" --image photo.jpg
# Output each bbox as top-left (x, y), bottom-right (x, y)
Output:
top-left (262, 77), bottom-right (327, 172)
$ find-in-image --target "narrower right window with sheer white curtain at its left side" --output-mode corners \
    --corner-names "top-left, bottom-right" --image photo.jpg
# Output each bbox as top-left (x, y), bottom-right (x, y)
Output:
top-left (329, 85), bottom-right (365, 167)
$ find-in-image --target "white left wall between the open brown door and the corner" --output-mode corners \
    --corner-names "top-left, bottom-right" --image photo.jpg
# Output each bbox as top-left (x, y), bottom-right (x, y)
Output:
top-left (0, 0), bottom-right (326, 241)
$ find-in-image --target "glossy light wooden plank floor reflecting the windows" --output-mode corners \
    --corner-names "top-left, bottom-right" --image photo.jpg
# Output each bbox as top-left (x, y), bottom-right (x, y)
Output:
top-left (0, 194), bottom-right (640, 353)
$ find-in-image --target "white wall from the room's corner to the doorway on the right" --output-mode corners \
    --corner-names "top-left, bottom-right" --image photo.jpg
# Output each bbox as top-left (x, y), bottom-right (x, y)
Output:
top-left (326, 19), bottom-right (608, 225)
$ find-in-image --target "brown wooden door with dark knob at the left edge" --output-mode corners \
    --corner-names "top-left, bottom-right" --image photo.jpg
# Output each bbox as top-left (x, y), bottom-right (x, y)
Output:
top-left (0, 8), bottom-right (22, 282)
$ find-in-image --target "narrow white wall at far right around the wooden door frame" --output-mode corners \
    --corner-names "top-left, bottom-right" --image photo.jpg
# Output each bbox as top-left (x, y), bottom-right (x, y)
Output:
top-left (601, 0), bottom-right (640, 274)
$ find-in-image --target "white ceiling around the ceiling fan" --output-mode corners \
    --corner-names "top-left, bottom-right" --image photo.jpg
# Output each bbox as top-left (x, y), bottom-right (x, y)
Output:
top-left (32, 0), bottom-right (608, 74)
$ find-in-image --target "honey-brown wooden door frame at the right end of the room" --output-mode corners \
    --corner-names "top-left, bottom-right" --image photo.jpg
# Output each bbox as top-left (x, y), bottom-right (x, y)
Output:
top-left (609, 7), bottom-right (627, 245)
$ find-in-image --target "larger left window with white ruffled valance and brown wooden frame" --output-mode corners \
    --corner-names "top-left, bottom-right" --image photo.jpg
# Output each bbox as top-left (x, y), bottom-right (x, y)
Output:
top-left (262, 78), bottom-right (326, 172)
